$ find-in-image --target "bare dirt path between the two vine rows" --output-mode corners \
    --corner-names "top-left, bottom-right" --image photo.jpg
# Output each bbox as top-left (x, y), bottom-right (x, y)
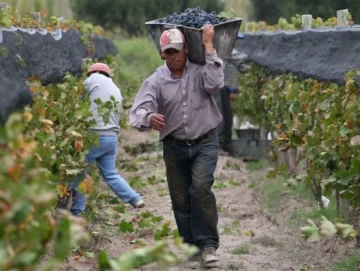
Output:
top-left (61, 131), bottom-right (354, 271)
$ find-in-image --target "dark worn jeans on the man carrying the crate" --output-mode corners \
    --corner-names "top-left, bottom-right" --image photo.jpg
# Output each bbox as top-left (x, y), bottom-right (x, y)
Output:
top-left (163, 133), bottom-right (219, 249)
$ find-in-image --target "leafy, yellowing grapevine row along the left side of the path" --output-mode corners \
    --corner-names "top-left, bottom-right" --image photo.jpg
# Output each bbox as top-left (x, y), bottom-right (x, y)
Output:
top-left (0, 4), bottom-right (197, 271)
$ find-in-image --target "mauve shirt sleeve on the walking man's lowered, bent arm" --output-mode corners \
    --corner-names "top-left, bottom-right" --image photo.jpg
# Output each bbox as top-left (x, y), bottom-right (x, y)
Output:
top-left (130, 79), bottom-right (158, 129)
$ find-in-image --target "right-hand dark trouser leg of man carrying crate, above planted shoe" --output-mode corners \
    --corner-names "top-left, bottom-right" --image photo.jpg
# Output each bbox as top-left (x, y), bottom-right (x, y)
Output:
top-left (190, 135), bottom-right (219, 249)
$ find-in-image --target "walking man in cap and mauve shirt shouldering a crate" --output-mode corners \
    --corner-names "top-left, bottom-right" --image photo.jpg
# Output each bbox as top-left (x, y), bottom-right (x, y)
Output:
top-left (130, 24), bottom-right (224, 265)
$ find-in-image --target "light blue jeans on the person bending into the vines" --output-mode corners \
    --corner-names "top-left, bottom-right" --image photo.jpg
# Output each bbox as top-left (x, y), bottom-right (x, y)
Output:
top-left (70, 136), bottom-right (141, 216)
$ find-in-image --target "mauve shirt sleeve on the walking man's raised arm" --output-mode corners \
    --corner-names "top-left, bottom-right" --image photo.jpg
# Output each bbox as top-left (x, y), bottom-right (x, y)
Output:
top-left (202, 50), bottom-right (224, 95)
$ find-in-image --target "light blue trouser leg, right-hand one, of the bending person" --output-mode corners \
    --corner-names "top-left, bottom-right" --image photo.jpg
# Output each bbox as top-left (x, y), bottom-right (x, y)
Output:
top-left (96, 136), bottom-right (141, 204)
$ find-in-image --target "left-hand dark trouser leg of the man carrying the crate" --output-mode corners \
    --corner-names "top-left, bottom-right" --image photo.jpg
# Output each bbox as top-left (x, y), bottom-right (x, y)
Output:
top-left (163, 142), bottom-right (195, 245)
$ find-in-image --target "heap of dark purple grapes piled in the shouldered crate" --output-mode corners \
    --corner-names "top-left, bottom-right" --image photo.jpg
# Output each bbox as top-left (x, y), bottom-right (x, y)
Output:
top-left (158, 7), bottom-right (227, 28)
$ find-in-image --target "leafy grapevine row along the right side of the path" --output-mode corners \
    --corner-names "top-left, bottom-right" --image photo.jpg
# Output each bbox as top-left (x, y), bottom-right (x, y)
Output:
top-left (233, 15), bottom-right (360, 243)
